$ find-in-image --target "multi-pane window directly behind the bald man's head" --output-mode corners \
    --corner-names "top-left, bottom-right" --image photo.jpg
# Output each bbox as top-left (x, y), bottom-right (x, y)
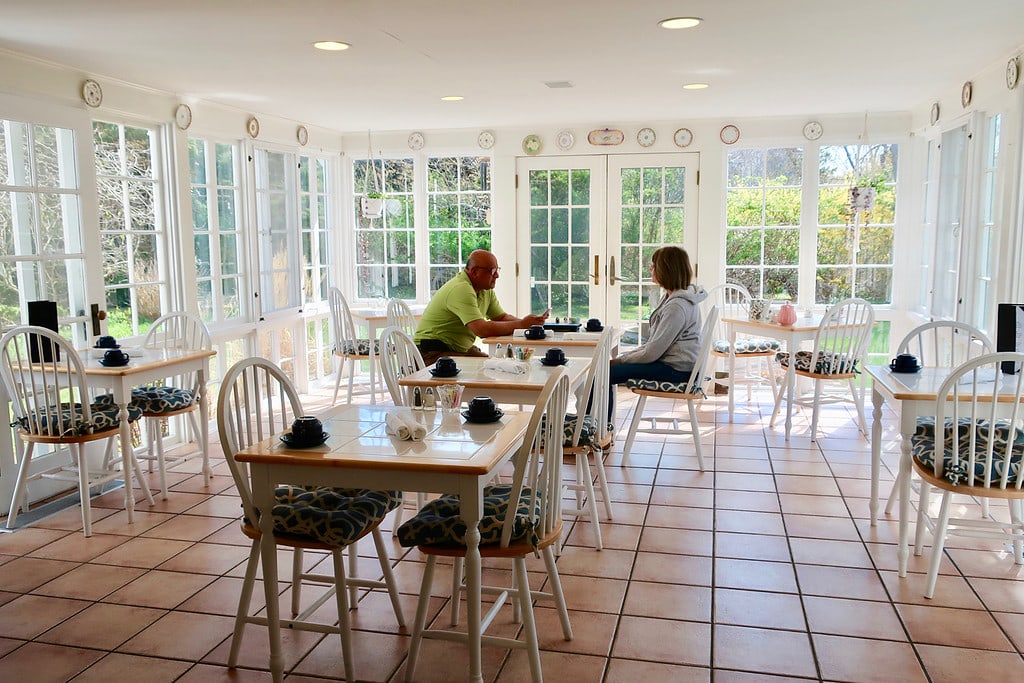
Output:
top-left (423, 157), bottom-right (490, 298)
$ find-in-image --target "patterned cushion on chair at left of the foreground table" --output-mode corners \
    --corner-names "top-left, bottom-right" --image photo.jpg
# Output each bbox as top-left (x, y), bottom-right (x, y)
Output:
top-left (271, 484), bottom-right (401, 548)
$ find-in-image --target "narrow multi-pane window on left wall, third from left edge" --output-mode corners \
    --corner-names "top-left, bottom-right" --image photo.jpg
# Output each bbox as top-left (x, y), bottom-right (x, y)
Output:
top-left (188, 138), bottom-right (248, 324)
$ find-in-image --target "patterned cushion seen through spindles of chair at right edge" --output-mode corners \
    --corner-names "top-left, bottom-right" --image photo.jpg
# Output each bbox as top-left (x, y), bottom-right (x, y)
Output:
top-left (910, 417), bottom-right (1024, 485)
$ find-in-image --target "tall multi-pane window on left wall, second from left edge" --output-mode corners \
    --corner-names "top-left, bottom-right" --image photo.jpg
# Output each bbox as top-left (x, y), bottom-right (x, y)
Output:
top-left (92, 121), bottom-right (164, 336)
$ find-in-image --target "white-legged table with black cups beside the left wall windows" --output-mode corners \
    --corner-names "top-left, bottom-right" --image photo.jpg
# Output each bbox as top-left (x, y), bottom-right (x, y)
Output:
top-left (79, 347), bottom-right (217, 523)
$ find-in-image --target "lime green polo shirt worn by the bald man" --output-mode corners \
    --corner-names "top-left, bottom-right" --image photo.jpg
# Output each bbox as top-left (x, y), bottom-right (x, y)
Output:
top-left (414, 270), bottom-right (505, 353)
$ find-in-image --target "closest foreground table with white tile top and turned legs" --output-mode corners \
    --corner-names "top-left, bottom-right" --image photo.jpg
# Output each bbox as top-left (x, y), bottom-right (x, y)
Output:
top-left (236, 405), bottom-right (530, 683)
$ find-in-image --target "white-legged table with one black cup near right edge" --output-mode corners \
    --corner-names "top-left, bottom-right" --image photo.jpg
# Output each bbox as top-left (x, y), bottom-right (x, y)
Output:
top-left (864, 366), bottom-right (1013, 577)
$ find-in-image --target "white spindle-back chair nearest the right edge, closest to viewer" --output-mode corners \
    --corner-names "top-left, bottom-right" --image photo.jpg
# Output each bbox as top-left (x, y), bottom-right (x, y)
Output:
top-left (910, 352), bottom-right (1024, 598)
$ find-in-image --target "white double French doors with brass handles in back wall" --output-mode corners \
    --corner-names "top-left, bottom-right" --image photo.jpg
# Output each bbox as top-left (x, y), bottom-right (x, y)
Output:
top-left (516, 154), bottom-right (699, 337)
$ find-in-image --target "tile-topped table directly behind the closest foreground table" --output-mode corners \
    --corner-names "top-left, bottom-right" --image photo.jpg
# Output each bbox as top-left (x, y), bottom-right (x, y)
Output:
top-left (398, 355), bottom-right (590, 405)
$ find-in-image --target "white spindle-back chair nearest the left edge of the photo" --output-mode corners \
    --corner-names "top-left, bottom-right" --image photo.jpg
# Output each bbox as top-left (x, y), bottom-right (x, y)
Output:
top-left (0, 325), bottom-right (155, 537)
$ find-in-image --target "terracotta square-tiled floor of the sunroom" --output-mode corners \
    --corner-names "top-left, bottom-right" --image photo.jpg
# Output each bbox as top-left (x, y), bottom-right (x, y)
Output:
top-left (0, 391), bottom-right (1024, 683)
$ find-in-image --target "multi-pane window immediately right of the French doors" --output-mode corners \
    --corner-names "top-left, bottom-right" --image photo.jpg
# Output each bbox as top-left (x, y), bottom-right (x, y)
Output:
top-left (725, 147), bottom-right (804, 300)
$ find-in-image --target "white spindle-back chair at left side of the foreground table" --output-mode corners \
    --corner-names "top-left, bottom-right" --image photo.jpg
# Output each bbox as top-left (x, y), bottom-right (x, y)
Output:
top-left (217, 357), bottom-right (404, 681)
